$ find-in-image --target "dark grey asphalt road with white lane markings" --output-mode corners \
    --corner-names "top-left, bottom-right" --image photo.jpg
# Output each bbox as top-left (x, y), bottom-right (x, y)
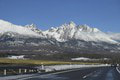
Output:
top-left (19, 67), bottom-right (120, 80)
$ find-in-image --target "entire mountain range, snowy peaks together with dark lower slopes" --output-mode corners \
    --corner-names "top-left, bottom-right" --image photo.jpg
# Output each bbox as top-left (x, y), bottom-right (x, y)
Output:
top-left (0, 20), bottom-right (120, 54)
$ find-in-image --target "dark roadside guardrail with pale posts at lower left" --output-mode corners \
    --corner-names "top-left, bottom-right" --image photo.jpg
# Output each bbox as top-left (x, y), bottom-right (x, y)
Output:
top-left (0, 66), bottom-right (38, 76)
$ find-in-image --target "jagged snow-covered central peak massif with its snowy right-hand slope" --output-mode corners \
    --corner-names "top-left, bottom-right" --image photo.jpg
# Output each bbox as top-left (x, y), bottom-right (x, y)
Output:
top-left (43, 22), bottom-right (117, 43)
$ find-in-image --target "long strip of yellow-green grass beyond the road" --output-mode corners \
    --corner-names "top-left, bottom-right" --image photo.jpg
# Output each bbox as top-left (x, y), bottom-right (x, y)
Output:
top-left (0, 58), bottom-right (99, 65)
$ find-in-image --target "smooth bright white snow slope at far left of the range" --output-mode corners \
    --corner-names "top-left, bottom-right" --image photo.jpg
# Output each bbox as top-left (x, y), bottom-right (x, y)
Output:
top-left (0, 20), bottom-right (40, 36)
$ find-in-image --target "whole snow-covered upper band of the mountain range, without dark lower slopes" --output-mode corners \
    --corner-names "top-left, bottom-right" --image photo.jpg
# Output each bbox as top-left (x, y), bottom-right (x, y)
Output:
top-left (0, 20), bottom-right (117, 43)
